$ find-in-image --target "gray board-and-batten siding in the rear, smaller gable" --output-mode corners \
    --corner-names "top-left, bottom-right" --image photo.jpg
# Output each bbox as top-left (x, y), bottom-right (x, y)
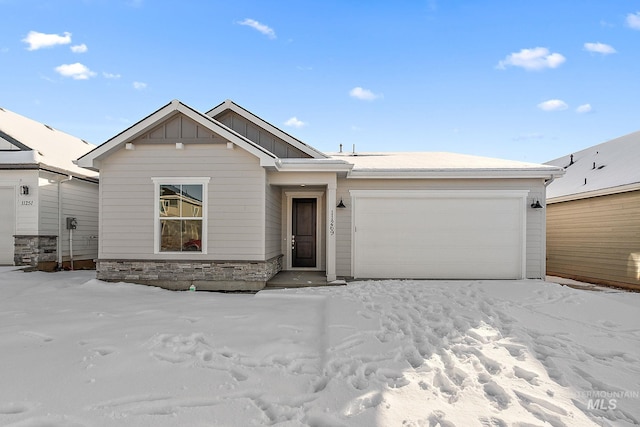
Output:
top-left (216, 111), bottom-right (310, 159)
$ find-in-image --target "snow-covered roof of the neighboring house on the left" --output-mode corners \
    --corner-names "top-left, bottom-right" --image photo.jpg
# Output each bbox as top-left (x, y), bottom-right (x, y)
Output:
top-left (0, 108), bottom-right (97, 178)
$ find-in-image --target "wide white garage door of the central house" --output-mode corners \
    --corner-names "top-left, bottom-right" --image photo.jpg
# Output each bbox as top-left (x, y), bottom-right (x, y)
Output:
top-left (351, 190), bottom-right (527, 279)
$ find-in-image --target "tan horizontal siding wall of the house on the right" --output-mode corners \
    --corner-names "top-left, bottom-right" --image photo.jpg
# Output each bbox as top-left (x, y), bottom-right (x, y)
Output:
top-left (546, 191), bottom-right (640, 289)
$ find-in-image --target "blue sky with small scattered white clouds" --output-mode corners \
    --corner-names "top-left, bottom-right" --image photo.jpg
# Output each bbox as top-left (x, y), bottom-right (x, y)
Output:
top-left (0, 0), bottom-right (640, 162)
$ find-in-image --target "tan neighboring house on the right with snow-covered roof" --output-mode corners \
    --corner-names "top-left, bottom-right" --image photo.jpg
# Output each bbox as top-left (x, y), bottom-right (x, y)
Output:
top-left (547, 132), bottom-right (640, 289)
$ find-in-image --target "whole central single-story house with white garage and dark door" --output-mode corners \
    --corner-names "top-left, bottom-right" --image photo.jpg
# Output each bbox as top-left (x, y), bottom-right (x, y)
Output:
top-left (78, 101), bottom-right (563, 289)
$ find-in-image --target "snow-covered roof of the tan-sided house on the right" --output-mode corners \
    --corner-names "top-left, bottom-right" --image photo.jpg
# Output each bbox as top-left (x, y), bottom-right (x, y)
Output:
top-left (546, 131), bottom-right (640, 201)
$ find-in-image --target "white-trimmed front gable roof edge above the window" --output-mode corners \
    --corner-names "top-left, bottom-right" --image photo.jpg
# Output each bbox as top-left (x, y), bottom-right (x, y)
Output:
top-left (78, 99), bottom-right (276, 170)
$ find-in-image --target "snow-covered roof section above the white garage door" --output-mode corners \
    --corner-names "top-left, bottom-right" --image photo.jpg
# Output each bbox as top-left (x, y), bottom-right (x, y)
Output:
top-left (331, 152), bottom-right (564, 179)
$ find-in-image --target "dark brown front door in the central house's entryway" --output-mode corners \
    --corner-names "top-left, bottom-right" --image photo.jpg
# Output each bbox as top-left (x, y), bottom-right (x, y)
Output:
top-left (291, 199), bottom-right (316, 267)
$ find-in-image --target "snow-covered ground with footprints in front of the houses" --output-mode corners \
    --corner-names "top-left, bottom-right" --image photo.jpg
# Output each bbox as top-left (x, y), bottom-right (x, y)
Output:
top-left (0, 268), bottom-right (640, 427)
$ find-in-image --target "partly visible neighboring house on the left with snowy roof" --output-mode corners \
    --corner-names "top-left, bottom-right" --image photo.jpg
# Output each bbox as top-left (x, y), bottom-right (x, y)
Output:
top-left (0, 108), bottom-right (98, 270)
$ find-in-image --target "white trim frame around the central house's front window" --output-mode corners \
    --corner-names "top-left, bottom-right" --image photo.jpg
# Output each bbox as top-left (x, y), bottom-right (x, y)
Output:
top-left (151, 177), bottom-right (211, 256)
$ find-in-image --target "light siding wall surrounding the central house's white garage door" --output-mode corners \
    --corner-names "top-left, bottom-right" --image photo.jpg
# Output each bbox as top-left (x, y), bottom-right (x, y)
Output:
top-left (336, 178), bottom-right (545, 279)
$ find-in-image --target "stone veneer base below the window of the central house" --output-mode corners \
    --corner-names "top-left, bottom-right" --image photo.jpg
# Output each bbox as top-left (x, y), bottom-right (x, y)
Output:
top-left (96, 255), bottom-right (282, 291)
